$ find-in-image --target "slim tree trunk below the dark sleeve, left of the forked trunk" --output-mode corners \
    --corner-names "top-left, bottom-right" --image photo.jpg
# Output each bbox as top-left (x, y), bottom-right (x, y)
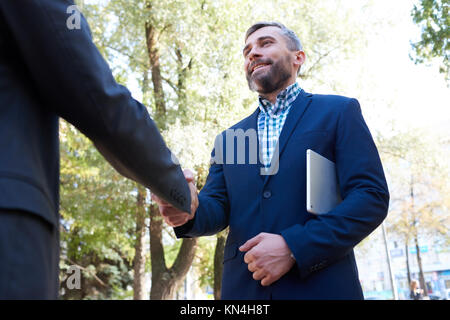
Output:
top-left (133, 186), bottom-right (147, 300)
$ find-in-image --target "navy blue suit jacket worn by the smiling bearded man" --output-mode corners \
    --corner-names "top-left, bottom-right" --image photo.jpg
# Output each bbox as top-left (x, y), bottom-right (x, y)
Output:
top-left (175, 91), bottom-right (389, 299)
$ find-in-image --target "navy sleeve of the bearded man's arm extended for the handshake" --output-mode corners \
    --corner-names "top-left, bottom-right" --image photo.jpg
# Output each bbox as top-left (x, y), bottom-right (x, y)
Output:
top-left (174, 151), bottom-right (230, 238)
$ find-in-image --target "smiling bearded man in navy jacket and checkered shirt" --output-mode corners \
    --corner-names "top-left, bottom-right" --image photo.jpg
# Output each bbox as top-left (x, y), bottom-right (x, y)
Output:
top-left (155, 23), bottom-right (389, 299)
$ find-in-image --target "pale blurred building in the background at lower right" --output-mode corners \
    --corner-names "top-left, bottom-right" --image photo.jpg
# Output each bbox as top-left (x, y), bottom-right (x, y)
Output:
top-left (355, 228), bottom-right (450, 300)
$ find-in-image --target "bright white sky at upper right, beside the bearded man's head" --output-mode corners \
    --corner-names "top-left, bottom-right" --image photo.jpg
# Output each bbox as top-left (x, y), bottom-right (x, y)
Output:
top-left (91, 0), bottom-right (450, 136)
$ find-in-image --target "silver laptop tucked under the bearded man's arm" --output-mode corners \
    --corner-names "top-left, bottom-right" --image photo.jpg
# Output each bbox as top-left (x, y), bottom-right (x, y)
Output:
top-left (306, 149), bottom-right (342, 214)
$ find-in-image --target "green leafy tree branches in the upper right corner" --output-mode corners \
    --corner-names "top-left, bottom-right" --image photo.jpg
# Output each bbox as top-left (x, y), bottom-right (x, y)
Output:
top-left (411, 0), bottom-right (450, 80)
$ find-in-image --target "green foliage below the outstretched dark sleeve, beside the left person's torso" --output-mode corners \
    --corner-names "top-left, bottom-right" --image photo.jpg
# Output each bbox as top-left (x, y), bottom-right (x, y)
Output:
top-left (60, 121), bottom-right (135, 298)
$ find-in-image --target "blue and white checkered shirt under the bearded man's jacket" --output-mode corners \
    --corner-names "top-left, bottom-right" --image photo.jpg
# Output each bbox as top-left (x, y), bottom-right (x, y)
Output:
top-left (258, 82), bottom-right (302, 168)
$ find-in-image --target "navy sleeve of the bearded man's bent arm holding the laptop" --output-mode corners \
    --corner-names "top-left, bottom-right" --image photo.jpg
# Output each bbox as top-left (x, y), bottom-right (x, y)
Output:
top-left (281, 99), bottom-right (389, 277)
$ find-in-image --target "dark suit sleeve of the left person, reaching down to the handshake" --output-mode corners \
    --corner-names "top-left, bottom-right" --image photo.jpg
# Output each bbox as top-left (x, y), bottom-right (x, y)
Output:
top-left (0, 0), bottom-right (191, 212)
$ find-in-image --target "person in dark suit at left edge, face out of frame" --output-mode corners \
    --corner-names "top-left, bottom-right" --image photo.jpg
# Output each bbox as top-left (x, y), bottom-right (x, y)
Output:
top-left (0, 0), bottom-right (191, 299)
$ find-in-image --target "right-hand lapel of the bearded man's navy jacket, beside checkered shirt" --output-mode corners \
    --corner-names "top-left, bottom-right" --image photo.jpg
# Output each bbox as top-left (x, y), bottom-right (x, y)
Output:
top-left (262, 90), bottom-right (312, 184)
